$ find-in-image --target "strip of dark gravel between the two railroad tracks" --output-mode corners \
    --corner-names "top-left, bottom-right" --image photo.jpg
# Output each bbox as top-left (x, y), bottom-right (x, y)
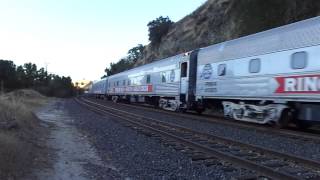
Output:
top-left (91, 99), bottom-right (320, 161)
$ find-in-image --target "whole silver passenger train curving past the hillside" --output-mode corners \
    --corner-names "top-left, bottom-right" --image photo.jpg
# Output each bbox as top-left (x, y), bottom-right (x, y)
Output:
top-left (89, 16), bottom-right (320, 127)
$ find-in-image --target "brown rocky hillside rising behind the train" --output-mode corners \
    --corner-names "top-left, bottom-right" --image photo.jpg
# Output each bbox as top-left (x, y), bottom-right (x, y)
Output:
top-left (136, 0), bottom-right (320, 66)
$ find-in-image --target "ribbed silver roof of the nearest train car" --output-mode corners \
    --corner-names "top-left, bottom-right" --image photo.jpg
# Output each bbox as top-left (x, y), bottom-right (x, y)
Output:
top-left (199, 16), bottom-right (320, 64)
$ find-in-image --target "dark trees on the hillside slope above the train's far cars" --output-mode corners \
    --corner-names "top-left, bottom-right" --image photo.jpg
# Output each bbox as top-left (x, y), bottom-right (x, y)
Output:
top-left (101, 16), bottom-right (173, 78)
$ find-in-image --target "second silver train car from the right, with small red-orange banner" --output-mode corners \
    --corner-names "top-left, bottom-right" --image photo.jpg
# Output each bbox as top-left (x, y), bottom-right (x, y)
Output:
top-left (108, 54), bottom-right (189, 110)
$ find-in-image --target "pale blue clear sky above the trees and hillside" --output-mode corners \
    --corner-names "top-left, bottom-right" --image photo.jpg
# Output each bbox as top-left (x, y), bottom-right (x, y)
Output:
top-left (0, 0), bottom-right (205, 80)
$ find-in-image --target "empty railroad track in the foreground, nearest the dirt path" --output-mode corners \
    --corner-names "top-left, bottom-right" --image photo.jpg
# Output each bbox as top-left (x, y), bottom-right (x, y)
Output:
top-left (76, 99), bottom-right (320, 179)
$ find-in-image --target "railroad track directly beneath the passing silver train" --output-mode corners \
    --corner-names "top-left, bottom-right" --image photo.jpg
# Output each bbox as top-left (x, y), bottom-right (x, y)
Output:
top-left (86, 97), bottom-right (320, 142)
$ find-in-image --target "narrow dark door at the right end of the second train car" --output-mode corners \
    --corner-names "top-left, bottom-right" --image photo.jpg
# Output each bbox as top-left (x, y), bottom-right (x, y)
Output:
top-left (180, 61), bottom-right (189, 102)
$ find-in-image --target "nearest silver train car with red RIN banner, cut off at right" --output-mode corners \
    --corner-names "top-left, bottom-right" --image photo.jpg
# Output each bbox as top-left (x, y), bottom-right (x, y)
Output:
top-left (195, 17), bottom-right (320, 125)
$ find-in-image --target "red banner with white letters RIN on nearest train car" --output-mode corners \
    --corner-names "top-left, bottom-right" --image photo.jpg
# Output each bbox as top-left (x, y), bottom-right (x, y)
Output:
top-left (275, 75), bottom-right (320, 94)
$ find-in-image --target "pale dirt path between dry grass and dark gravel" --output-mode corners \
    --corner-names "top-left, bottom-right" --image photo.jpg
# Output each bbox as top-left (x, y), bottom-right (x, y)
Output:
top-left (36, 100), bottom-right (112, 180)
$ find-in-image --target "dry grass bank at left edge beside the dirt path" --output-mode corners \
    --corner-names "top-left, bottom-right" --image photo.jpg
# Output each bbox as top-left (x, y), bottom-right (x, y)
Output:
top-left (0, 90), bottom-right (48, 179)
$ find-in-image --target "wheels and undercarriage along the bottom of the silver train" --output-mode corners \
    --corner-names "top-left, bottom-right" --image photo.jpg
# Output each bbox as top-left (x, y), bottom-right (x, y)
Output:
top-left (103, 95), bottom-right (320, 128)
